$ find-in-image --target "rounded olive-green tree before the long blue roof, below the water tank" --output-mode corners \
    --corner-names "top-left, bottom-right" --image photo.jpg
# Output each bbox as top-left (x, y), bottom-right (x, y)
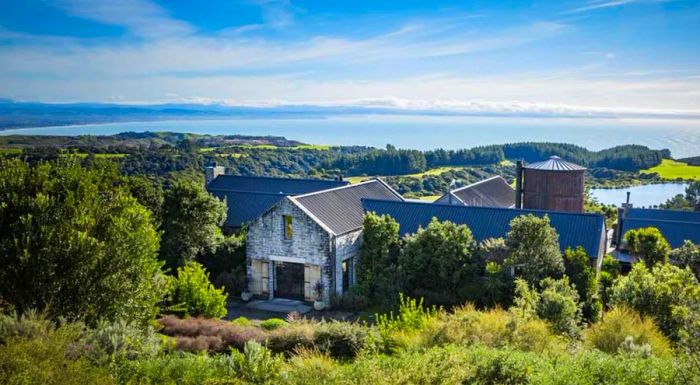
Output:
top-left (506, 214), bottom-right (564, 284)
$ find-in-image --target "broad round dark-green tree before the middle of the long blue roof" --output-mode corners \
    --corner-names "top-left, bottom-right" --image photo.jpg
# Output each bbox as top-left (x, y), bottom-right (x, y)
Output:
top-left (399, 218), bottom-right (478, 302)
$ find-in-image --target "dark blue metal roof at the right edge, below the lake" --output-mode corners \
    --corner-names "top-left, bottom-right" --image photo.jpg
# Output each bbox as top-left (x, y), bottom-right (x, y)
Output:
top-left (621, 208), bottom-right (700, 248)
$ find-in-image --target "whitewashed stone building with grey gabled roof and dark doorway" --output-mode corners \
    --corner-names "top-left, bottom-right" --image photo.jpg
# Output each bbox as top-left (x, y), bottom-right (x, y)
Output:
top-left (246, 179), bottom-right (403, 304)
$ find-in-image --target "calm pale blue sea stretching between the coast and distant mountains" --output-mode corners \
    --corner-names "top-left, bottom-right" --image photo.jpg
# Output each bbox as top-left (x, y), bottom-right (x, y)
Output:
top-left (0, 115), bottom-right (700, 158)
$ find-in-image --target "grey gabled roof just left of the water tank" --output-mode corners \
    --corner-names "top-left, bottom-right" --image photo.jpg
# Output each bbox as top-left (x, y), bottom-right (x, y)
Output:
top-left (435, 176), bottom-right (515, 207)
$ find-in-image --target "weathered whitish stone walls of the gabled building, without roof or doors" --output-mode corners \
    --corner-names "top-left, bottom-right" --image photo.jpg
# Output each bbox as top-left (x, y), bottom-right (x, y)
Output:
top-left (246, 198), bottom-right (362, 305)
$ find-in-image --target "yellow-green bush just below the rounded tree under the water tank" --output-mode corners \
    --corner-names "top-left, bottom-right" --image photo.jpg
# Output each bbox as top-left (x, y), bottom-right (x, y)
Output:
top-left (512, 276), bottom-right (581, 336)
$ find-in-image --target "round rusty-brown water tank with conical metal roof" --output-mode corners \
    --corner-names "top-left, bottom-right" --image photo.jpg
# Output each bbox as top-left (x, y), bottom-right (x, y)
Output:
top-left (518, 156), bottom-right (586, 212)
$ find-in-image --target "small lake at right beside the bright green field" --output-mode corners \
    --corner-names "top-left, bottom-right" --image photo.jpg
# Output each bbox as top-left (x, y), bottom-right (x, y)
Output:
top-left (591, 183), bottom-right (688, 207)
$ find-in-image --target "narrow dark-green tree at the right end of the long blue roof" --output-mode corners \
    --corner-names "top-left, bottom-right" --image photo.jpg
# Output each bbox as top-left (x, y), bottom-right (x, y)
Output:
top-left (564, 246), bottom-right (602, 323)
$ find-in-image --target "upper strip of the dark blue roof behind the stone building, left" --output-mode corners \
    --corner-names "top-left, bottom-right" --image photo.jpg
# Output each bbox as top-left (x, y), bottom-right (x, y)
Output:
top-left (207, 175), bottom-right (348, 195)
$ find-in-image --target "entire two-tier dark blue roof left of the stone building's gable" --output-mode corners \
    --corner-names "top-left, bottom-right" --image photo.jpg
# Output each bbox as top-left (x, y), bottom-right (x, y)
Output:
top-left (207, 175), bottom-right (347, 227)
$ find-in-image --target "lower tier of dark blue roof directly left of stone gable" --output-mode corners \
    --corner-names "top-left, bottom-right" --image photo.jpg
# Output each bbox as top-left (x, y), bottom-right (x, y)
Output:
top-left (211, 191), bottom-right (285, 227)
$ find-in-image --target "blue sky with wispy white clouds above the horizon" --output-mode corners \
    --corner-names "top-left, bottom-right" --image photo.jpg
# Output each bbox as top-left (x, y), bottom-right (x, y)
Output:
top-left (0, 0), bottom-right (700, 115)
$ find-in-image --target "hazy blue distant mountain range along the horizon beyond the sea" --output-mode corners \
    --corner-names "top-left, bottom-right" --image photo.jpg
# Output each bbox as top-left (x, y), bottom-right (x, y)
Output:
top-left (0, 98), bottom-right (700, 130)
